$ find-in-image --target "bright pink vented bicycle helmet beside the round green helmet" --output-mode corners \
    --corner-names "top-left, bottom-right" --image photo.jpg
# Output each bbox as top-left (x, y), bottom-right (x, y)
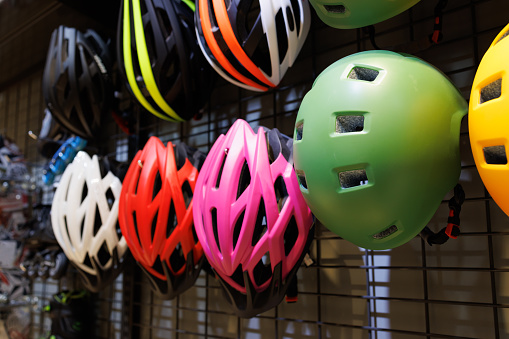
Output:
top-left (193, 119), bottom-right (314, 317)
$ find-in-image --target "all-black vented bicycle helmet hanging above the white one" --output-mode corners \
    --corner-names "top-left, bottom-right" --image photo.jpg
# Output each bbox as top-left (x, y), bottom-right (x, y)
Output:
top-left (42, 26), bottom-right (112, 139)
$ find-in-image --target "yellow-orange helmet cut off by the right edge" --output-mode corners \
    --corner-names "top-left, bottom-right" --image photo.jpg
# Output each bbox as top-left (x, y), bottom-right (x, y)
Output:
top-left (468, 25), bottom-right (509, 215)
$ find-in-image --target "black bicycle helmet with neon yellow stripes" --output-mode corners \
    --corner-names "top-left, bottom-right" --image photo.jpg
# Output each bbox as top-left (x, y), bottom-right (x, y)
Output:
top-left (117, 0), bottom-right (213, 122)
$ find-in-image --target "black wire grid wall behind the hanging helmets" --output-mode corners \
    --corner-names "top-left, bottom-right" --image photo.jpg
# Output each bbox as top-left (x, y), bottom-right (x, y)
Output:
top-left (0, 0), bottom-right (509, 339)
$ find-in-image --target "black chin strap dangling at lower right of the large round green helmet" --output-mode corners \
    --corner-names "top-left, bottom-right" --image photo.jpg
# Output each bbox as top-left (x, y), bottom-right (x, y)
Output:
top-left (419, 184), bottom-right (465, 246)
